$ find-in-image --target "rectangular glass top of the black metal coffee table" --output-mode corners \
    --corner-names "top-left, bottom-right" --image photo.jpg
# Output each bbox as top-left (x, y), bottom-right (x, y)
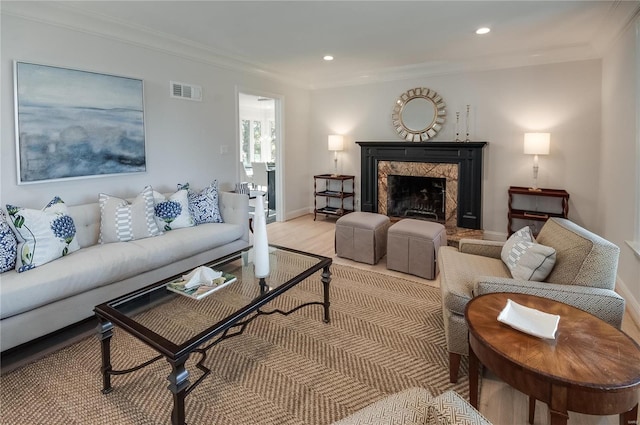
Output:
top-left (95, 246), bottom-right (331, 355)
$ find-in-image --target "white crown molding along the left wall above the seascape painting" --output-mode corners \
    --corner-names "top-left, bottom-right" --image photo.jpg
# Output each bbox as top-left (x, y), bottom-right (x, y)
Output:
top-left (0, 1), bottom-right (310, 89)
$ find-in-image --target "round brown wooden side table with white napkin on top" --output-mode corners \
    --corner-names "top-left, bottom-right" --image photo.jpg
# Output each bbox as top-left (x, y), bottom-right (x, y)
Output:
top-left (465, 293), bottom-right (640, 425)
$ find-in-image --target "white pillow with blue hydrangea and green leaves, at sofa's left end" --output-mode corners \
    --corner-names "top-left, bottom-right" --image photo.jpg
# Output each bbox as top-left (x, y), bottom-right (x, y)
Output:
top-left (7, 196), bottom-right (80, 272)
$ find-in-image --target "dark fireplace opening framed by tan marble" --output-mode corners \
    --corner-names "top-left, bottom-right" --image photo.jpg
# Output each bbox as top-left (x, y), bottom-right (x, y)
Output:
top-left (387, 174), bottom-right (447, 224)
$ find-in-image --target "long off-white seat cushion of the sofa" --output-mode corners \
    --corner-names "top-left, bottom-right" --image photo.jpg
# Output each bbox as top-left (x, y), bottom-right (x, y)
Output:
top-left (0, 223), bottom-right (244, 319)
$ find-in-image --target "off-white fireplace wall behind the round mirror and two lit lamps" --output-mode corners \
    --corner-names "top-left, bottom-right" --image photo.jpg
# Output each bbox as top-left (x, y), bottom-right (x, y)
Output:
top-left (310, 60), bottom-right (601, 237)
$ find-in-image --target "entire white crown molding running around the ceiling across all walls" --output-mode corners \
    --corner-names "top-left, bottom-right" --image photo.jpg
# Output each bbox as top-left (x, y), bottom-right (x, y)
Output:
top-left (0, 0), bottom-right (640, 90)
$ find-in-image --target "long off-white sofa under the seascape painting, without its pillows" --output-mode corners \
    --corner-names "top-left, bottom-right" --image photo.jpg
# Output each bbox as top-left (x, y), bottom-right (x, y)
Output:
top-left (0, 192), bottom-right (250, 351)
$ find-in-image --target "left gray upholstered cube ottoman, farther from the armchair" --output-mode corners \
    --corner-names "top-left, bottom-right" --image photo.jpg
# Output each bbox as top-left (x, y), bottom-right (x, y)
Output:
top-left (335, 211), bottom-right (389, 264)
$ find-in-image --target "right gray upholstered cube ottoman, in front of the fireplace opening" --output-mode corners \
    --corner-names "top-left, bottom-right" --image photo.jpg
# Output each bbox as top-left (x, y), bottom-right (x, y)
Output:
top-left (387, 218), bottom-right (447, 279)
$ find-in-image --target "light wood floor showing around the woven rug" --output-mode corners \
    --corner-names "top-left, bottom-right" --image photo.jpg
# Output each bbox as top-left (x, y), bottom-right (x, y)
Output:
top-left (267, 214), bottom-right (640, 425)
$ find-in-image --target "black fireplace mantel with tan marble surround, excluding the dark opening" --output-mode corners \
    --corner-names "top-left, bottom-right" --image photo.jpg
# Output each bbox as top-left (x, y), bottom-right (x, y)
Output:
top-left (356, 141), bottom-right (487, 234)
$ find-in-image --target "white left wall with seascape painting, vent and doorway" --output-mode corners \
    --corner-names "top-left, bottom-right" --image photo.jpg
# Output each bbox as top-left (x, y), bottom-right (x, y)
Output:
top-left (0, 14), bottom-right (309, 215)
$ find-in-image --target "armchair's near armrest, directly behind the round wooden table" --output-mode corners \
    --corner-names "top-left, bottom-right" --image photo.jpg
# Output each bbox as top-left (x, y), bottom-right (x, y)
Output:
top-left (473, 276), bottom-right (625, 329)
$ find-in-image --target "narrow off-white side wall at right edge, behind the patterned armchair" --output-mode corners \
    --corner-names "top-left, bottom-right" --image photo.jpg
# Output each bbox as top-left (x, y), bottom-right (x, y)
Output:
top-left (595, 19), bottom-right (640, 323)
